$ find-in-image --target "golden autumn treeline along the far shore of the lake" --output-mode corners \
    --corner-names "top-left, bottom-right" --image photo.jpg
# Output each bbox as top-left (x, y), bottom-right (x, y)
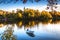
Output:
top-left (0, 8), bottom-right (60, 22)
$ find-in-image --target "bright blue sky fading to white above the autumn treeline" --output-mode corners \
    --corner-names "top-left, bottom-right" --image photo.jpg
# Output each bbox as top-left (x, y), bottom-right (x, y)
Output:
top-left (0, 0), bottom-right (60, 11)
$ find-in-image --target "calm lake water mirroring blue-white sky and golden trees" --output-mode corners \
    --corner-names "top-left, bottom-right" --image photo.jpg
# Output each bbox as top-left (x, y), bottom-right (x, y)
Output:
top-left (0, 21), bottom-right (60, 40)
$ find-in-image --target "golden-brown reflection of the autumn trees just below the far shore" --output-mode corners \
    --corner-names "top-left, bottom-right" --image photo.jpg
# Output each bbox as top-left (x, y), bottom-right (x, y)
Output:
top-left (16, 20), bottom-right (60, 28)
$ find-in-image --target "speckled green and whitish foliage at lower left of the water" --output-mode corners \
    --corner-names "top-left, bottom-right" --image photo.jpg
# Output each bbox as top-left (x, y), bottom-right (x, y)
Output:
top-left (1, 25), bottom-right (16, 40)
